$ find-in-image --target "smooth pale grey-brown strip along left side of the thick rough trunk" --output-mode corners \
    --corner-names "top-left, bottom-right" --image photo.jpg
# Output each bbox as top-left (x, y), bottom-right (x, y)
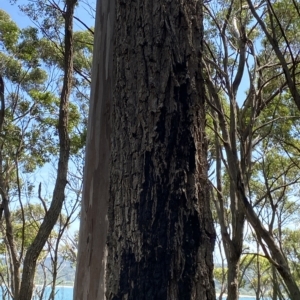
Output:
top-left (74, 1), bottom-right (115, 300)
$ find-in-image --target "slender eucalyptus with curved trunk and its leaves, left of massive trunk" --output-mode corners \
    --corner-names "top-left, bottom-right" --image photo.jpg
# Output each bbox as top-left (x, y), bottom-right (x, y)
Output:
top-left (0, 1), bottom-right (93, 299)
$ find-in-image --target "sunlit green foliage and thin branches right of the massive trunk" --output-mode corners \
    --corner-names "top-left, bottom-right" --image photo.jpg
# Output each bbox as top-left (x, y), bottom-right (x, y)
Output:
top-left (203, 0), bottom-right (300, 297)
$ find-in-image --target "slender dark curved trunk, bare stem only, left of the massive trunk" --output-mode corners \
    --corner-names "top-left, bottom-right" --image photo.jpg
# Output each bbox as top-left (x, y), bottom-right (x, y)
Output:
top-left (18, 0), bottom-right (77, 300)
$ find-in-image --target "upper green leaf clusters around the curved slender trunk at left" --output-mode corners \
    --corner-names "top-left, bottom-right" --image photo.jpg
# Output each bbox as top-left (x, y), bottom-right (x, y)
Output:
top-left (0, 6), bottom-right (93, 182)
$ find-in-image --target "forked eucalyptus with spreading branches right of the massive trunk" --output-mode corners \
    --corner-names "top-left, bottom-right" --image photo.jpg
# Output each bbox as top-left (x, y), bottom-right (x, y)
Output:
top-left (203, 1), bottom-right (300, 299)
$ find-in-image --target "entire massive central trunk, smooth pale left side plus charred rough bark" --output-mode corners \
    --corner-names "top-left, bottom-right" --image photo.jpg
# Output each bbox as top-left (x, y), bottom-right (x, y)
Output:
top-left (74, 0), bottom-right (215, 300)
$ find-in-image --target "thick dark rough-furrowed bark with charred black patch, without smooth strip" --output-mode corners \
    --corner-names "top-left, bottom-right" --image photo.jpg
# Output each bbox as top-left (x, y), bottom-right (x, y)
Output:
top-left (106, 1), bottom-right (214, 300)
